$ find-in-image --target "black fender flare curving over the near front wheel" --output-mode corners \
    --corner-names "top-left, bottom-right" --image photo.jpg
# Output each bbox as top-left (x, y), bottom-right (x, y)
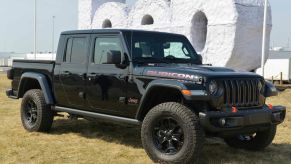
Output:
top-left (136, 79), bottom-right (187, 120)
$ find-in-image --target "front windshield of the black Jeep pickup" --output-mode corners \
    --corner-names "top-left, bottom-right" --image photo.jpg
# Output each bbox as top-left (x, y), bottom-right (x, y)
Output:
top-left (131, 32), bottom-right (198, 63)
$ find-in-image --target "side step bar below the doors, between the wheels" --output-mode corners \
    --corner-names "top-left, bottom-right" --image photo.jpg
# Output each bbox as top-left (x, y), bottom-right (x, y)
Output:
top-left (52, 106), bottom-right (141, 125)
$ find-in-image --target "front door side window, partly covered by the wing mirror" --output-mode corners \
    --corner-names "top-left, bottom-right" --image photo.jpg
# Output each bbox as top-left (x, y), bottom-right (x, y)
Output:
top-left (93, 37), bottom-right (123, 64)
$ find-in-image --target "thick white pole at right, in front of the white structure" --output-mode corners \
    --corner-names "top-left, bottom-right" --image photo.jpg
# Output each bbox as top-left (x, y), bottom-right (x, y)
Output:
top-left (261, 0), bottom-right (269, 77)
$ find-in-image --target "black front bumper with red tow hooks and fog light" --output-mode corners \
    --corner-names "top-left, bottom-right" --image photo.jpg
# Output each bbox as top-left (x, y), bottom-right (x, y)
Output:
top-left (199, 106), bottom-right (286, 135)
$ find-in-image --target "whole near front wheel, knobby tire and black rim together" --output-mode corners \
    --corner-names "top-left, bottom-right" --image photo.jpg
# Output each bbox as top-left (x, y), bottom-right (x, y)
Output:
top-left (141, 102), bottom-right (204, 163)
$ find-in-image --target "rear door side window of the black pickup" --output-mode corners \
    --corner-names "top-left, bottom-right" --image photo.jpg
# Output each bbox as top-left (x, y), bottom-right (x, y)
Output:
top-left (64, 37), bottom-right (87, 63)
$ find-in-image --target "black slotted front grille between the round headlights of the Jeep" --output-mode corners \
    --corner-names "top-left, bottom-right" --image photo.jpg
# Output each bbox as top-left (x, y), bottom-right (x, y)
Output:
top-left (222, 79), bottom-right (260, 107)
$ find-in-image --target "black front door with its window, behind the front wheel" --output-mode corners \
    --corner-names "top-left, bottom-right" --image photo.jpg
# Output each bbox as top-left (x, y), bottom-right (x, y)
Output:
top-left (87, 35), bottom-right (133, 117)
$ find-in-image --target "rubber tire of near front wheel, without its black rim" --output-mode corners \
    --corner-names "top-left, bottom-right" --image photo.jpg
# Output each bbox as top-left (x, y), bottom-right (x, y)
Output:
top-left (141, 102), bottom-right (204, 163)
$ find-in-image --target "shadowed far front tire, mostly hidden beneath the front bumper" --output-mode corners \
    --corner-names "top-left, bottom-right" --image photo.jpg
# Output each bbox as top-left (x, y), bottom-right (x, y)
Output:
top-left (224, 125), bottom-right (277, 151)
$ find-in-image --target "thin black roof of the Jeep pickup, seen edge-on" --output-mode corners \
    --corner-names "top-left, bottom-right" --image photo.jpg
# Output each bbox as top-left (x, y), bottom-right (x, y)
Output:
top-left (61, 28), bottom-right (185, 35)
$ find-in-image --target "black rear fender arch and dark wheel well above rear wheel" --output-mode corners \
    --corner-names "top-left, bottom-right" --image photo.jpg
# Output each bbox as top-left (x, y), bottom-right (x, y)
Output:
top-left (17, 72), bottom-right (54, 105)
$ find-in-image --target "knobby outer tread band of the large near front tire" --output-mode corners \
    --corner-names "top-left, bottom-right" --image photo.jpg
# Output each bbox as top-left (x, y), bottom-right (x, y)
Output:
top-left (141, 102), bottom-right (204, 163)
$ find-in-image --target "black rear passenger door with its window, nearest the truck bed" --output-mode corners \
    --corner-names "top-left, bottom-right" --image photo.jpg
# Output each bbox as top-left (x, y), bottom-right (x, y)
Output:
top-left (60, 34), bottom-right (90, 109)
